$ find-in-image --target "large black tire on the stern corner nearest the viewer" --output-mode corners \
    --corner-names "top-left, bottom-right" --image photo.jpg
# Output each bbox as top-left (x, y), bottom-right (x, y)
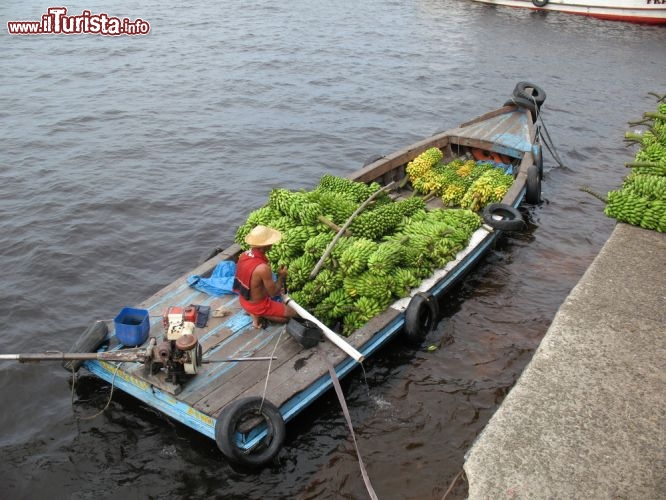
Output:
top-left (215, 396), bottom-right (287, 468)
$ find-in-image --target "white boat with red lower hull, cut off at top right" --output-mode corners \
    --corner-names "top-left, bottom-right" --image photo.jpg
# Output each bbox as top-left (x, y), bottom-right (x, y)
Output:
top-left (466, 0), bottom-right (666, 24)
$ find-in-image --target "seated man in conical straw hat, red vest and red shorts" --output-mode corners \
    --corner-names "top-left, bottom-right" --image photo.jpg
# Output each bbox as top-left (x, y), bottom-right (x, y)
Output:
top-left (233, 225), bottom-right (298, 328)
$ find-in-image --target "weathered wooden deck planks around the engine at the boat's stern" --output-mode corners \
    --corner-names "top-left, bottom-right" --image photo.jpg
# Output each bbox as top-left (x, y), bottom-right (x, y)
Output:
top-left (107, 170), bottom-right (488, 417)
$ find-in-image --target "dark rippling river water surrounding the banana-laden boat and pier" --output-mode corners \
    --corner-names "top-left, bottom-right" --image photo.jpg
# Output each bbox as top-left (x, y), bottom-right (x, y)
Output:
top-left (0, 0), bottom-right (666, 499)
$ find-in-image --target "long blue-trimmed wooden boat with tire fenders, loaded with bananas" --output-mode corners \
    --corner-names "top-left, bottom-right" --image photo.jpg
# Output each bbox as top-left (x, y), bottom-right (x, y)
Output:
top-left (67, 82), bottom-right (545, 466)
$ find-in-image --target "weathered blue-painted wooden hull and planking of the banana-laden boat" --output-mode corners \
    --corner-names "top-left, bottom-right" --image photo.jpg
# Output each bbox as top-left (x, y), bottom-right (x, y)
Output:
top-left (76, 86), bottom-right (540, 464)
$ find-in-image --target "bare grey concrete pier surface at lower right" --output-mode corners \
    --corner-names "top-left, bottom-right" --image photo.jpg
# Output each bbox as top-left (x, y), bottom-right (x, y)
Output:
top-left (464, 223), bottom-right (666, 500)
